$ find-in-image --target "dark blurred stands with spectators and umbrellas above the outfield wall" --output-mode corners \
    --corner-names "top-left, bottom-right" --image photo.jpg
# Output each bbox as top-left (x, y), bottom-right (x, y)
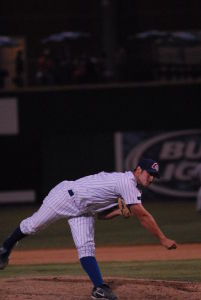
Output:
top-left (0, 0), bottom-right (201, 89)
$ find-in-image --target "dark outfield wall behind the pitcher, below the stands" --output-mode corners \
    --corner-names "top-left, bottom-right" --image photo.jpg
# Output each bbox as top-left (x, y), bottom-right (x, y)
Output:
top-left (0, 83), bottom-right (201, 200)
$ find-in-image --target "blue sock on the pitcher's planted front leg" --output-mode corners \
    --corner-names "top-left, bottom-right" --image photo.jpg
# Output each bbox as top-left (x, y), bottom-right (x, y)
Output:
top-left (80, 256), bottom-right (104, 287)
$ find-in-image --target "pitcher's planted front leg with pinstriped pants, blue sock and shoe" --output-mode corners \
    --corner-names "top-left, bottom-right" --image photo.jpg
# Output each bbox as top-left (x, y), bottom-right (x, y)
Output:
top-left (68, 216), bottom-right (117, 300)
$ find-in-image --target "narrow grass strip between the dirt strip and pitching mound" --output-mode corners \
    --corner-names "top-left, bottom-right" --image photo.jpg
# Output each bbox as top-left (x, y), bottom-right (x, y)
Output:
top-left (0, 260), bottom-right (201, 282)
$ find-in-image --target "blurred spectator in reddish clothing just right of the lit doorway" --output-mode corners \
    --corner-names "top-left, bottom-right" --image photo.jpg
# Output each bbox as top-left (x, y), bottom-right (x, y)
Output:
top-left (36, 48), bottom-right (55, 85)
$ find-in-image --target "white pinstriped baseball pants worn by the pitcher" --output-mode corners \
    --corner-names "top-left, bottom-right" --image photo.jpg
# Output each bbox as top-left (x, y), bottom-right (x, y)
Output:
top-left (20, 183), bottom-right (95, 258)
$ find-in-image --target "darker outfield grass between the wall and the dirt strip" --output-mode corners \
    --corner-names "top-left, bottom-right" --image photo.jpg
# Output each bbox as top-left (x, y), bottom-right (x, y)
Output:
top-left (0, 201), bottom-right (201, 249)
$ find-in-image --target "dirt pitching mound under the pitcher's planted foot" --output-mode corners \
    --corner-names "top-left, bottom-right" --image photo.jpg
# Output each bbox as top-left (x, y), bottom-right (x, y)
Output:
top-left (0, 276), bottom-right (201, 300)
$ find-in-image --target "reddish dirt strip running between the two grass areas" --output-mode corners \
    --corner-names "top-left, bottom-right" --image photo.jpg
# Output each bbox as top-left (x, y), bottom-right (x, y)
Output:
top-left (10, 244), bottom-right (201, 264)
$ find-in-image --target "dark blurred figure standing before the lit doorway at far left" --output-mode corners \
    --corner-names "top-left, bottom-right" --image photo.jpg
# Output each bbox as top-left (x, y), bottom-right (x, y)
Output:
top-left (13, 50), bottom-right (24, 87)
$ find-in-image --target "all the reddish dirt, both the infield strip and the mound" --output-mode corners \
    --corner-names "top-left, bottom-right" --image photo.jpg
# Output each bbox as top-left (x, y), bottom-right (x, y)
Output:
top-left (0, 244), bottom-right (201, 300)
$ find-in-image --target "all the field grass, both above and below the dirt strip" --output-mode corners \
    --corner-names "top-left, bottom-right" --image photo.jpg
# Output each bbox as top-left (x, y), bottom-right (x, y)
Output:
top-left (0, 201), bottom-right (201, 281)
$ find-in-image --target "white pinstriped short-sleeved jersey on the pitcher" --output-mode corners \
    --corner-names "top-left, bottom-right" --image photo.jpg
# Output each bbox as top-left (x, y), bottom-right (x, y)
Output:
top-left (72, 171), bottom-right (141, 212)
